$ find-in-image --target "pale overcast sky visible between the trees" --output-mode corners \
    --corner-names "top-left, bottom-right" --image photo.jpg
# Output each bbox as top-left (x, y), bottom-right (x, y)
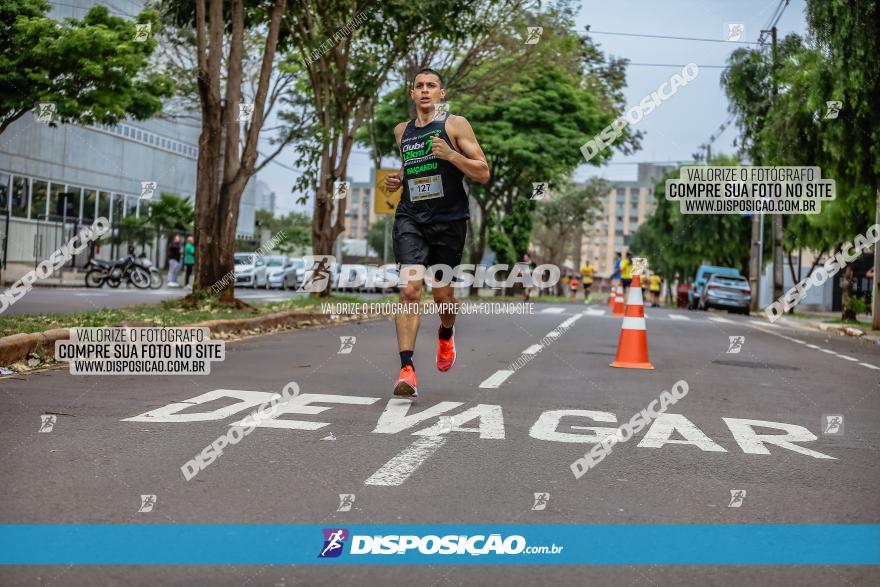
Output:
top-left (259, 0), bottom-right (806, 213)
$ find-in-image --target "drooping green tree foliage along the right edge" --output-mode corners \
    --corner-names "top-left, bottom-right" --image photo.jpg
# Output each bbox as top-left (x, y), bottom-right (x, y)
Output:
top-left (723, 0), bottom-right (880, 319)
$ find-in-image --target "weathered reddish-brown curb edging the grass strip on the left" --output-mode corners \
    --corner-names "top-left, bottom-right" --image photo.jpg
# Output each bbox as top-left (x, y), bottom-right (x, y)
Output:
top-left (0, 311), bottom-right (383, 367)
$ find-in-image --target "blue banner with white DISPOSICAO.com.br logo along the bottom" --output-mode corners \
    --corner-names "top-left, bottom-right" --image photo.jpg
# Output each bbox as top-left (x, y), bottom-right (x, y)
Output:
top-left (0, 524), bottom-right (880, 565)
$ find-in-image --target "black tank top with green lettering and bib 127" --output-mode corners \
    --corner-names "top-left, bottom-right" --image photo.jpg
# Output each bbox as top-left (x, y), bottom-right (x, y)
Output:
top-left (395, 113), bottom-right (470, 223)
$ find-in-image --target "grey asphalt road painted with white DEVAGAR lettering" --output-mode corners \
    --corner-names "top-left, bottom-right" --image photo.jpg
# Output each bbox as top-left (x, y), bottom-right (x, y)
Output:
top-left (0, 304), bottom-right (880, 587)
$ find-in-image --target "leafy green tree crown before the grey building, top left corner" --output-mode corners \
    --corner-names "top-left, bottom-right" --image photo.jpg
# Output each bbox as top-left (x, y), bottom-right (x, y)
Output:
top-left (0, 0), bottom-right (173, 133)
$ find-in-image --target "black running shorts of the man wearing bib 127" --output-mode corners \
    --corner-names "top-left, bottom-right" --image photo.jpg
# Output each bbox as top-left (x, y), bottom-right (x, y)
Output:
top-left (392, 216), bottom-right (467, 269)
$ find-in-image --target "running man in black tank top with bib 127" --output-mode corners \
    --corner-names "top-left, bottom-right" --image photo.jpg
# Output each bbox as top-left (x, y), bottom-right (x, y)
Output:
top-left (385, 69), bottom-right (489, 397)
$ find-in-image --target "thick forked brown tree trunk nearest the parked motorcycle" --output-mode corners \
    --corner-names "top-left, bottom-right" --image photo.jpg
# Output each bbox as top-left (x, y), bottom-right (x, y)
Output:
top-left (161, 0), bottom-right (290, 302)
